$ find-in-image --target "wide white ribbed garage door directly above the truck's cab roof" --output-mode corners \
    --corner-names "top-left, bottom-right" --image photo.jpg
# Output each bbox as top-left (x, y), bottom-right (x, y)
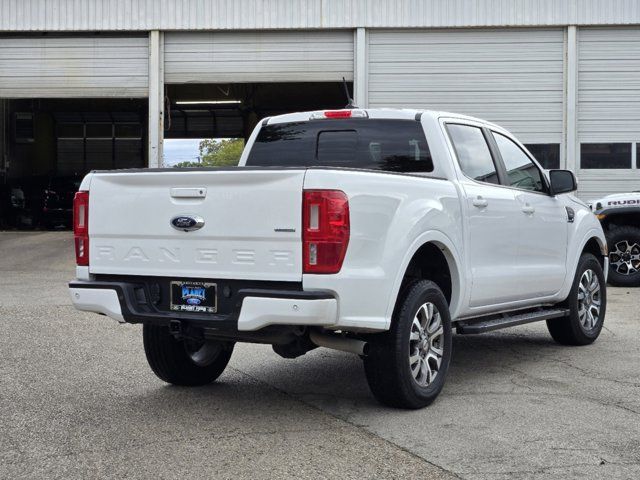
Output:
top-left (369, 29), bottom-right (564, 143)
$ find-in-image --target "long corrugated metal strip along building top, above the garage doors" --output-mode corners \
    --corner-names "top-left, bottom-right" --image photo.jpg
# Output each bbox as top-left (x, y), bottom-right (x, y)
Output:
top-left (0, 0), bottom-right (640, 31)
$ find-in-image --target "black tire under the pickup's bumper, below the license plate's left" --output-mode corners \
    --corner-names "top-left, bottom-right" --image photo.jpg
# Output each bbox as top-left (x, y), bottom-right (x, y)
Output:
top-left (142, 324), bottom-right (234, 387)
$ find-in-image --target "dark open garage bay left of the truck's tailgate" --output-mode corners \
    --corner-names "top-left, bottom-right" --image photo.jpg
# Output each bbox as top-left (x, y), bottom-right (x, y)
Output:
top-left (0, 99), bottom-right (148, 228)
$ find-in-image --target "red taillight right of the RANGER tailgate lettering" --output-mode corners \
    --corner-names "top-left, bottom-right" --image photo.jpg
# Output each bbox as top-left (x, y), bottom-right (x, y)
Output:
top-left (302, 190), bottom-right (349, 273)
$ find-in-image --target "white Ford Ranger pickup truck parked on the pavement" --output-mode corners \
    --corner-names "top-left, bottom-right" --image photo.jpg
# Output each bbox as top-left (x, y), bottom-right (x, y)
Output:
top-left (69, 109), bottom-right (608, 408)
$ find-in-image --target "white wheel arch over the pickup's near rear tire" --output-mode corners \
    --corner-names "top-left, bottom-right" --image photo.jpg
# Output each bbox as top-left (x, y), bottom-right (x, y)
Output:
top-left (386, 232), bottom-right (464, 328)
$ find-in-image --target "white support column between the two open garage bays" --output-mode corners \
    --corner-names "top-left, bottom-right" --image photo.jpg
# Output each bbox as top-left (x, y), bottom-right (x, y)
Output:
top-left (148, 30), bottom-right (164, 168)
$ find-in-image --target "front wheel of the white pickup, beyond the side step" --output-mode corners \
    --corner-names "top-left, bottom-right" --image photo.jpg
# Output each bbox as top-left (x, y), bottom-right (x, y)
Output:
top-left (547, 253), bottom-right (607, 345)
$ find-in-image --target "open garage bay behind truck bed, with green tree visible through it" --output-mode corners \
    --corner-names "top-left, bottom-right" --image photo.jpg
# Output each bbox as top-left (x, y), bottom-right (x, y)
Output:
top-left (163, 81), bottom-right (353, 167)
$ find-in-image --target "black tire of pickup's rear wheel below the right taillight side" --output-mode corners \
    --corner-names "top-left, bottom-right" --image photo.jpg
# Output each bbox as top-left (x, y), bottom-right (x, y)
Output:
top-left (364, 280), bottom-right (452, 409)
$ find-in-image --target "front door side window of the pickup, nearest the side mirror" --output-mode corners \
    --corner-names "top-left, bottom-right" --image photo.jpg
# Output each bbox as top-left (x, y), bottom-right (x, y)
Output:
top-left (492, 132), bottom-right (546, 192)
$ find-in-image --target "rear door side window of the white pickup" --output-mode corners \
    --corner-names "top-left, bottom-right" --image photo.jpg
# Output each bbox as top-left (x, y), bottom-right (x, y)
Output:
top-left (447, 123), bottom-right (500, 184)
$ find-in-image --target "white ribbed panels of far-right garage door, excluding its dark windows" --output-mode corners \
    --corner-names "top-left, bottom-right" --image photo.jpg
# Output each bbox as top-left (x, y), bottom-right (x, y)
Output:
top-left (577, 27), bottom-right (640, 198)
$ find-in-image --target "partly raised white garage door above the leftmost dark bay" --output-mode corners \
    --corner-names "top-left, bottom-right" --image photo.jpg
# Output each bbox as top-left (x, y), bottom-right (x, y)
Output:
top-left (0, 36), bottom-right (149, 98)
